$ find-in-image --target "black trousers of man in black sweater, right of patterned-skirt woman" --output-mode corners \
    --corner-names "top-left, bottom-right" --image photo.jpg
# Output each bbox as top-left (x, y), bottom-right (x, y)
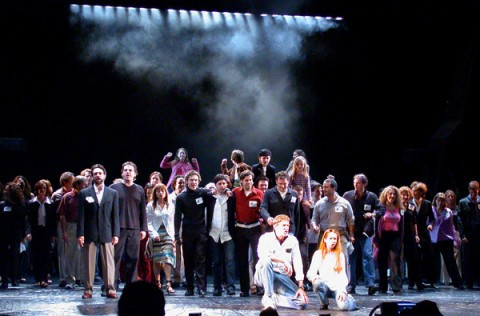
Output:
top-left (182, 230), bottom-right (208, 291)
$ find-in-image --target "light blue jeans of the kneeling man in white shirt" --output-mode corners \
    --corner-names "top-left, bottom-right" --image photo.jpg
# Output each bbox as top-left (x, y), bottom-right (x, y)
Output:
top-left (255, 259), bottom-right (307, 309)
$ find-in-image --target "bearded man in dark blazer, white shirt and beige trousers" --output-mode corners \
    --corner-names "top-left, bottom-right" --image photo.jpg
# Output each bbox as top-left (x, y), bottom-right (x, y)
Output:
top-left (77, 164), bottom-right (120, 299)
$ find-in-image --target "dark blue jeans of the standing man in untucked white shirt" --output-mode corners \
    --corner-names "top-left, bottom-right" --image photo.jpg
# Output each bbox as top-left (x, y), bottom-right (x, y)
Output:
top-left (209, 237), bottom-right (235, 289)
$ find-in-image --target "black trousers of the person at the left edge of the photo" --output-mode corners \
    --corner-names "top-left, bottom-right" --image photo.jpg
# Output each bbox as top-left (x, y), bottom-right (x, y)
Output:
top-left (0, 234), bottom-right (20, 283)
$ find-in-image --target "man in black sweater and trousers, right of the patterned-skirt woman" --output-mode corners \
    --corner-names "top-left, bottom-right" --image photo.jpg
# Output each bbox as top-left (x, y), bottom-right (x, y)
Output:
top-left (175, 170), bottom-right (213, 297)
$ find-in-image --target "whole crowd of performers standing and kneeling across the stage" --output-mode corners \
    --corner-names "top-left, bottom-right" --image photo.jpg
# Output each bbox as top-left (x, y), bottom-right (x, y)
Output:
top-left (0, 148), bottom-right (480, 310)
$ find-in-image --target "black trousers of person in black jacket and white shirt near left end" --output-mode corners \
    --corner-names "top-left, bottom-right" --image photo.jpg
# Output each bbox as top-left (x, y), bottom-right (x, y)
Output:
top-left (32, 226), bottom-right (52, 282)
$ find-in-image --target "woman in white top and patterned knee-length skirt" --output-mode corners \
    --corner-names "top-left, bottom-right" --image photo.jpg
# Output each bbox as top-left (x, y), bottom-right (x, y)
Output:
top-left (147, 183), bottom-right (175, 294)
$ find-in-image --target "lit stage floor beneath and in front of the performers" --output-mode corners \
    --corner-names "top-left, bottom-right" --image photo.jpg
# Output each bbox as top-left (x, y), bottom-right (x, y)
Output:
top-left (0, 283), bottom-right (480, 316)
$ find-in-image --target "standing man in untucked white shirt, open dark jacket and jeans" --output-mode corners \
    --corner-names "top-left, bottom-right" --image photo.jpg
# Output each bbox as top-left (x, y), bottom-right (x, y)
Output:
top-left (207, 174), bottom-right (235, 296)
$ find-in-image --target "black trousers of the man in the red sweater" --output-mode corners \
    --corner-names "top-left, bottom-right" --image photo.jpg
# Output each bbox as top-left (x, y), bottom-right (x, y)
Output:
top-left (235, 225), bottom-right (262, 293)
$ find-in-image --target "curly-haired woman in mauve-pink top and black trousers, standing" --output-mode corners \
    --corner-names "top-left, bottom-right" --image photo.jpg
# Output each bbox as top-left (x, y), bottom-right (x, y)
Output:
top-left (374, 185), bottom-right (403, 293)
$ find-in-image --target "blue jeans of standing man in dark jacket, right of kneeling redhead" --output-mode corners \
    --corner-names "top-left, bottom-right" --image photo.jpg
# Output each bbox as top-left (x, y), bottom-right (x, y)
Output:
top-left (349, 235), bottom-right (375, 289)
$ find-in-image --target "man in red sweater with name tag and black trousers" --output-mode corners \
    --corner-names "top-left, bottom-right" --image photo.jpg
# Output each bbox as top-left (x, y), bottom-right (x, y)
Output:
top-left (231, 170), bottom-right (263, 297)
